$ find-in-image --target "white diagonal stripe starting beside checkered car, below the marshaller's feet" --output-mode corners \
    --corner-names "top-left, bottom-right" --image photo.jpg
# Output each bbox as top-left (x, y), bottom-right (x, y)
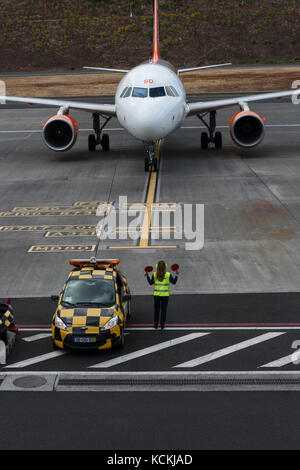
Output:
top-left (89, 333), bottom-right (210, 369)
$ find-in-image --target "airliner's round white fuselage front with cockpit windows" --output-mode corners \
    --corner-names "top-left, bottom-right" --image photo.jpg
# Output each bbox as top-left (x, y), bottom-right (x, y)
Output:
top-left (115, 60), bottom-right (187, 142)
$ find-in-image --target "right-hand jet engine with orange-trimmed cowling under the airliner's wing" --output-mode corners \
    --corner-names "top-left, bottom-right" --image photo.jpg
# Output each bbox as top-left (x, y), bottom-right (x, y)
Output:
top-left (230, 110), bottom-right (266, 147)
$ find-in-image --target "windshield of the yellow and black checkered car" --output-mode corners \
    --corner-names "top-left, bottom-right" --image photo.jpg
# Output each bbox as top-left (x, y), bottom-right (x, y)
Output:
top-left (62, 279), bottom-right (115, 306)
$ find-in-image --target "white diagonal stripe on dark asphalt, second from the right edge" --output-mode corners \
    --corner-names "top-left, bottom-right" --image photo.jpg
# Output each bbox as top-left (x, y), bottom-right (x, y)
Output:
top-left (174, 332), bottom-right (285, 367)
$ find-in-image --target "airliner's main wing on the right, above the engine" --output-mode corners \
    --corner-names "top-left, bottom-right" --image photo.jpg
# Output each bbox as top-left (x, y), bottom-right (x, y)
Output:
top-left (186, 89), bottom-right (300, 117)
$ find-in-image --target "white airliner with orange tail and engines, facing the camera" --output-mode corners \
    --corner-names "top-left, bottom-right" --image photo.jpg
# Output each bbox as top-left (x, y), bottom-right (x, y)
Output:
top-left (0, 0), bottom-right (300, 171)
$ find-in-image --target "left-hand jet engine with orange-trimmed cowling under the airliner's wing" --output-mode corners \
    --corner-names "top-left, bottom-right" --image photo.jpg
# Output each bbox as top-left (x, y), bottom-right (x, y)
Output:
top-left (42, 114), bottom-right (78, 152)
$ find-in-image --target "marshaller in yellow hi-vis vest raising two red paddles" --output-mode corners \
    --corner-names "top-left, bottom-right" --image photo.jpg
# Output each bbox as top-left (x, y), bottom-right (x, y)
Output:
top-left (145, 261), bottom-right (179, 330)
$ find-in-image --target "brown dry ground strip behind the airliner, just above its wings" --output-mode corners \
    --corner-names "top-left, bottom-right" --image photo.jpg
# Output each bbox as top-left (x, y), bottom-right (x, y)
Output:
top-left (4, 66), bottom-right (300, 97)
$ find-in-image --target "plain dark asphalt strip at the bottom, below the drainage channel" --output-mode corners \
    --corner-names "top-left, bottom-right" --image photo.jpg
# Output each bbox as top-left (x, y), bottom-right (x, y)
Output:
top-left (0, 392), bottom-right (300, 450)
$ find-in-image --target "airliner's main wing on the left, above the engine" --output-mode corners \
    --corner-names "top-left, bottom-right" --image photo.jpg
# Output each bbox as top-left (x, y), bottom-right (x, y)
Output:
top-left (0, 96), bottom-right (116, 116)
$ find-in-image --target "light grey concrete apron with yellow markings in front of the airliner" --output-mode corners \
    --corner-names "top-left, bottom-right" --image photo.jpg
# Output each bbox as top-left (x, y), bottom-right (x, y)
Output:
top-left (0, 95), bottom-right (300, 297)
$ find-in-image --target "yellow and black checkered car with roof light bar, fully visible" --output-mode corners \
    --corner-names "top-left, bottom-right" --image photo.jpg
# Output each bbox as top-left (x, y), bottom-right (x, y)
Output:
top-left (51, 258), bottom-right (131, 349)
